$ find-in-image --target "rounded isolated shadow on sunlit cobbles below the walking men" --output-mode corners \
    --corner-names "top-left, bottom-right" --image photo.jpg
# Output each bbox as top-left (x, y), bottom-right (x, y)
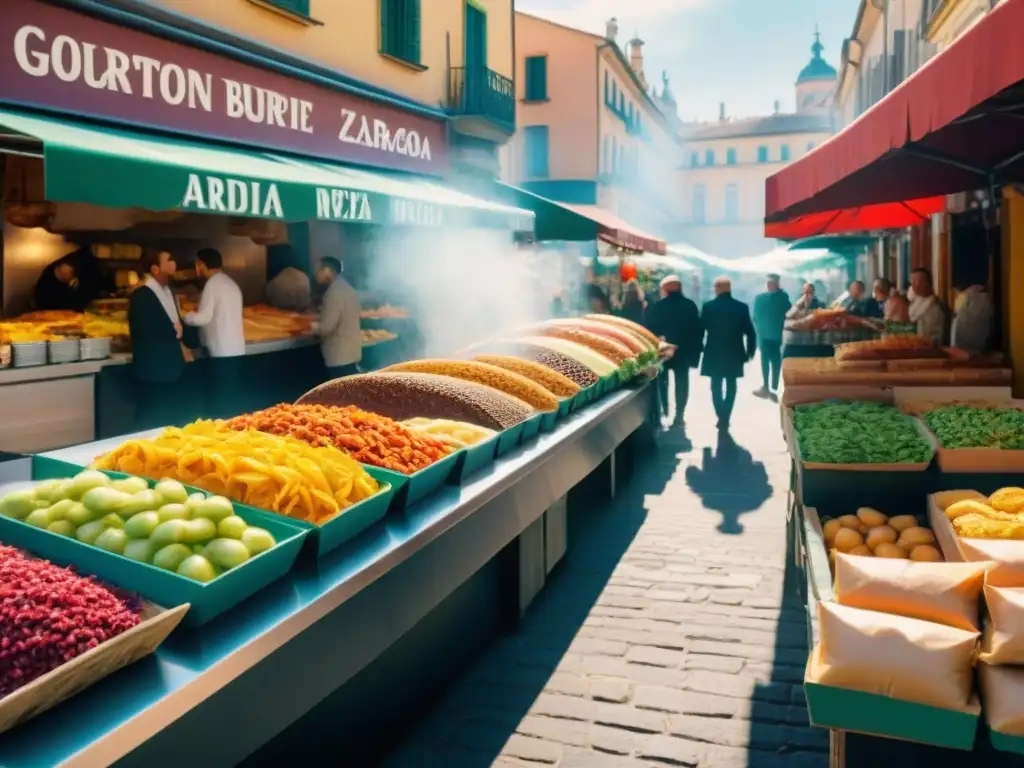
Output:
top-left (686, 430), bottom-right (772, 534)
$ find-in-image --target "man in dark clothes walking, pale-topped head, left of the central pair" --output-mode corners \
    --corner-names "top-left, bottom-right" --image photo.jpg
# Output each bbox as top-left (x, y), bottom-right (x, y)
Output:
top-left (647, 274), bottom-right (701, 424)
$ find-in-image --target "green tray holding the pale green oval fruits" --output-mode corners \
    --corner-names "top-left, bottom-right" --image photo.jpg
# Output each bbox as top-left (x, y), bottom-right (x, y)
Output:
top-left (0, 456), bottom-right (307, 627)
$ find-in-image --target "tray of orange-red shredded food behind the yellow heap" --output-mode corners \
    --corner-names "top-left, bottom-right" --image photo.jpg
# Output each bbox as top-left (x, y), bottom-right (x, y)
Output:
top-left (228, 404), bottom-right (462, 514)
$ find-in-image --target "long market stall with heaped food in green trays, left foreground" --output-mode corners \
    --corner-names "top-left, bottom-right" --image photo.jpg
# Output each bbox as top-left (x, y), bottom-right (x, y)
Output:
top-left (0, 315), bottom-right (658, 766)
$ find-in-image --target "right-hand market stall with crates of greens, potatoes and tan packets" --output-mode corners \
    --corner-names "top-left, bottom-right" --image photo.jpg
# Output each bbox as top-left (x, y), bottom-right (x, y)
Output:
top-left (781, 329), bottom-right (1024, 766)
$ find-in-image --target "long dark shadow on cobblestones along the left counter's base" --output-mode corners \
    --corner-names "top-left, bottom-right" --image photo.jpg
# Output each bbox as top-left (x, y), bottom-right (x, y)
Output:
top-left (381, 436), bottom-right (677, 768)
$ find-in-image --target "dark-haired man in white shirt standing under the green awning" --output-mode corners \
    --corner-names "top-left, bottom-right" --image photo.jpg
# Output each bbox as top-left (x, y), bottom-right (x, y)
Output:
top-left (183, 248), bottom-right (246, 419)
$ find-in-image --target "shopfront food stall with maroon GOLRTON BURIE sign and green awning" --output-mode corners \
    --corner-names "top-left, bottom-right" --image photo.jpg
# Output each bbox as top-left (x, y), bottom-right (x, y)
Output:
top-left (0, 0), bottom-right (534, 451)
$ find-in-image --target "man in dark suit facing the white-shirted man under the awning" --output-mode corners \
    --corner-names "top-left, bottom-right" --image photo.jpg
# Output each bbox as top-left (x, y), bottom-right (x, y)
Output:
top-left (128, 251), bottom-right (199, 430)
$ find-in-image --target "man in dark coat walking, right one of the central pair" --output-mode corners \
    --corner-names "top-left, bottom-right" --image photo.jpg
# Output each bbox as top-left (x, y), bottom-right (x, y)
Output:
top-left (700, 278), bottom-right (758, 429)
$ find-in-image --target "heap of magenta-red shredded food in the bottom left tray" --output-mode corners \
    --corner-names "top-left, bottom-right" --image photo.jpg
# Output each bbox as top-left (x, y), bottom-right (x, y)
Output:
top-left (0, 546), bottom-right (141, 698)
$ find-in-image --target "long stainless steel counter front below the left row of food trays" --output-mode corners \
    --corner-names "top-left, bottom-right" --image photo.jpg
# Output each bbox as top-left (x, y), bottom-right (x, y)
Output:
top-left (0, 385), bottom-right (652, 768)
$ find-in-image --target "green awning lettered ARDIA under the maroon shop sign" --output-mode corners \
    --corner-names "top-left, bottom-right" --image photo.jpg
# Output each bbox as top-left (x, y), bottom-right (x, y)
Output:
top-left (0, 110), bottom-right (534, 231)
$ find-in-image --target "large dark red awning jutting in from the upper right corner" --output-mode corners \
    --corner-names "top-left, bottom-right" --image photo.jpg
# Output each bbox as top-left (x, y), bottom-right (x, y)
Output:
top-left (765, 0), bottom-right (1024, 222)
